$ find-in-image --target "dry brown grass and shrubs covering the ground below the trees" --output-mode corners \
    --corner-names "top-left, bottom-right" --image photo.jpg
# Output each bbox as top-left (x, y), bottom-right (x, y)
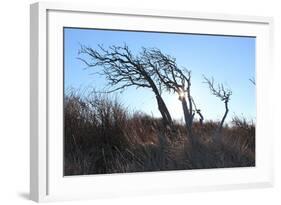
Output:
top-left (64, 92), bottom-right (255, 175)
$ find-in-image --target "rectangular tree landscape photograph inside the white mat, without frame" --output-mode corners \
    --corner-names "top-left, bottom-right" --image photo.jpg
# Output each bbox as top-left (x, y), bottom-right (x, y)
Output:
top-left (63, 27), bottom-right (256, 176)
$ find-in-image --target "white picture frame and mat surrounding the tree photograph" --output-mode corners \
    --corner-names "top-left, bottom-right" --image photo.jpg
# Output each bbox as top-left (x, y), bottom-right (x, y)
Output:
top-left (30, 2), bottom-right (273, 202)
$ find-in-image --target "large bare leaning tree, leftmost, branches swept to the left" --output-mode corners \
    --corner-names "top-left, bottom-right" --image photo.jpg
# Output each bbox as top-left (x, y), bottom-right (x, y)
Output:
top-left (79, 45), bottom-right (172, 126)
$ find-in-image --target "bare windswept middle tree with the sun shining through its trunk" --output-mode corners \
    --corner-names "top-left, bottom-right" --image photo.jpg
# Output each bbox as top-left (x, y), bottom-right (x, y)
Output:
top-left (142, 48), bottom-right (204, 143)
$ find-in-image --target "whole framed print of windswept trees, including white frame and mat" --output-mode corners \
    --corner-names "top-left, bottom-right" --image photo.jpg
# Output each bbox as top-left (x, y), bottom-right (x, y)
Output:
top-left (30, 3), bottom-right (273, 201)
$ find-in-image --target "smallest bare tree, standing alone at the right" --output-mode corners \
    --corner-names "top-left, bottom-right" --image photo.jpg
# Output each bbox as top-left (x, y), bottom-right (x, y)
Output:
top-left (203, 76), bottom-right (232, 142)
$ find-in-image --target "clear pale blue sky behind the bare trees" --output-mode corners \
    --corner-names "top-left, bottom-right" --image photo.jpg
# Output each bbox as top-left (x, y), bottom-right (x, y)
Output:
top-left (64, 28), bottom-right (256, 122)
